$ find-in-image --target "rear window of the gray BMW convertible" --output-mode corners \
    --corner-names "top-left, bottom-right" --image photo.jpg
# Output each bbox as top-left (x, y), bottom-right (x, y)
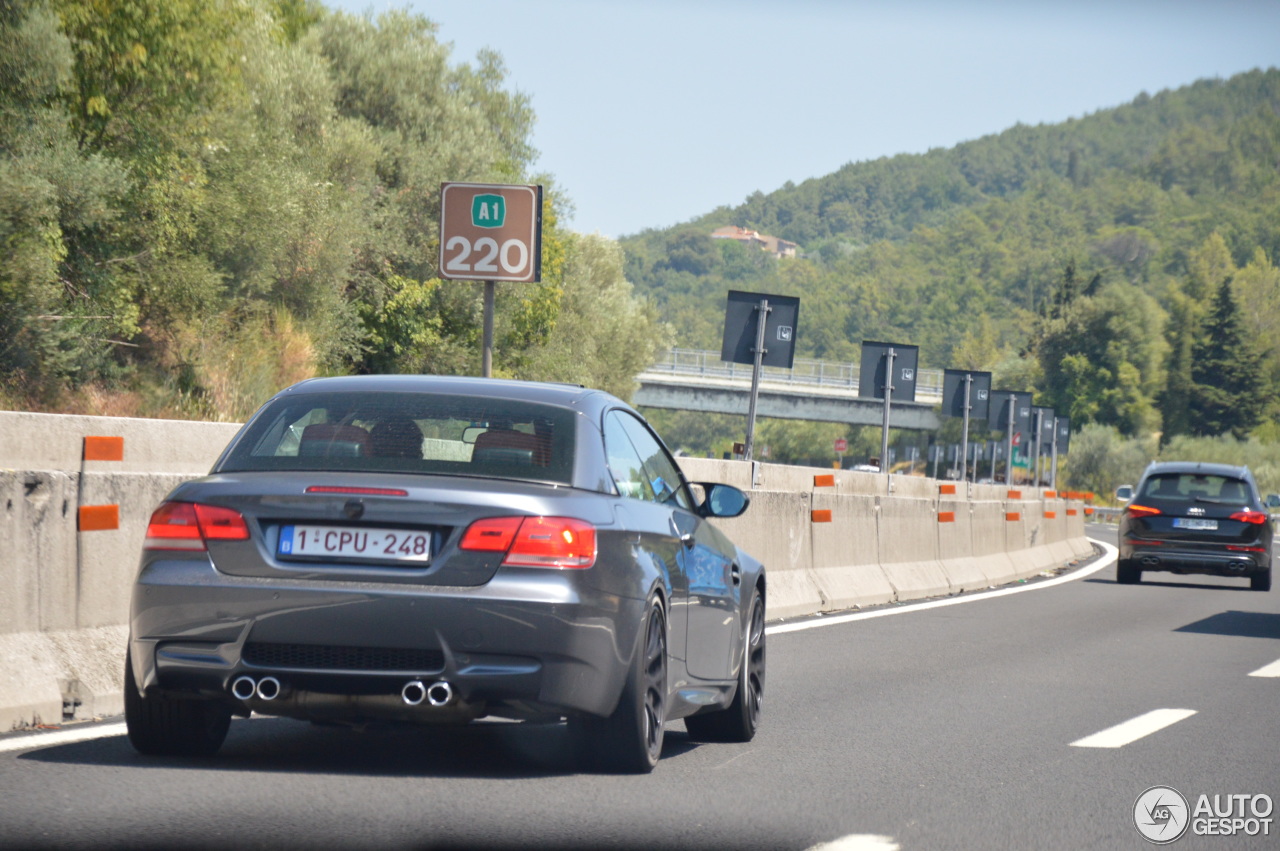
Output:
top-left (216, 392), bottom-right (573, 484)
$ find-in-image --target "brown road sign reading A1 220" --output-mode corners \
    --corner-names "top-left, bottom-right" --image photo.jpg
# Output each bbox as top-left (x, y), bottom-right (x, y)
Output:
top-left (439, 183), bottom-right (543, 283)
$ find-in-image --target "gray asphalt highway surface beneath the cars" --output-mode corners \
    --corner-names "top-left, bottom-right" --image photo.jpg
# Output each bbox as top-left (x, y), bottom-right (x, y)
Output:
top-left (0, 527), bottom-right (1280, 848)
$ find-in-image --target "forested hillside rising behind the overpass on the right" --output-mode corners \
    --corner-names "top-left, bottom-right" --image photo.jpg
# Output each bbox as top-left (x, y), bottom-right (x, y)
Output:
top-left (623, 69), bottom-right (1280, 440)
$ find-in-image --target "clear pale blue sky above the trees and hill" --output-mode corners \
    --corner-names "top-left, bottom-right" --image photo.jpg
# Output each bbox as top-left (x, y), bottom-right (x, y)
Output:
top-left (324, 0), bottom-right (1280, 237)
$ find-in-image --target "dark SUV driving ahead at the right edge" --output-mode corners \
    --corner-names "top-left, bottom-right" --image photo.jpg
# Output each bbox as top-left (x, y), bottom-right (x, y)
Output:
top-left (1116, 462), bottom-right (1274, 591)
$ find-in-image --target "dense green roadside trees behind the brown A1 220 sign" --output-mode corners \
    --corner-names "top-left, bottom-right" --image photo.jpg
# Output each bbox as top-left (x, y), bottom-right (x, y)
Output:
top-left (0, 0), bottom-right (664, 420)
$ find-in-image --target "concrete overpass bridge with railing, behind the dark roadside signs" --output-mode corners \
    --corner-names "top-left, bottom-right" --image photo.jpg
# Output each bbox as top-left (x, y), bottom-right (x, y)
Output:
top-left (631, 348), bottom-right (942, 431)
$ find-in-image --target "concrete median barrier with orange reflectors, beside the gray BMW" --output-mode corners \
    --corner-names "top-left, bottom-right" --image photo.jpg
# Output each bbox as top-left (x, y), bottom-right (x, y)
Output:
top-left (0, 411), bottom-right (1092, 731)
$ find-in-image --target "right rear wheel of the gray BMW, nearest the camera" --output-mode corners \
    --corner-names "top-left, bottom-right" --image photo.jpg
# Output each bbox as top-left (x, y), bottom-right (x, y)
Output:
top-left (570, 601), bottom-right (667, 774)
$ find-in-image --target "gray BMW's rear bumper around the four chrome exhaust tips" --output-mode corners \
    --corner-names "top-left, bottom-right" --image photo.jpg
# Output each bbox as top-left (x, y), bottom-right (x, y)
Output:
top-left (129, 558), bottom-right (645, 723)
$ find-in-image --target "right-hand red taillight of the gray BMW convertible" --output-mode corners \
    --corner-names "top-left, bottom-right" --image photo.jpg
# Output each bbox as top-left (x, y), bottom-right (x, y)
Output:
top-left (458, 517), bottom-right (595, 569)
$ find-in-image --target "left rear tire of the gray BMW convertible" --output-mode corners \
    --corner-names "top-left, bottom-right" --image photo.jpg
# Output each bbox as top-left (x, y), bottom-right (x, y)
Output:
top-left (124, 654), bottom-right (232, 756)
